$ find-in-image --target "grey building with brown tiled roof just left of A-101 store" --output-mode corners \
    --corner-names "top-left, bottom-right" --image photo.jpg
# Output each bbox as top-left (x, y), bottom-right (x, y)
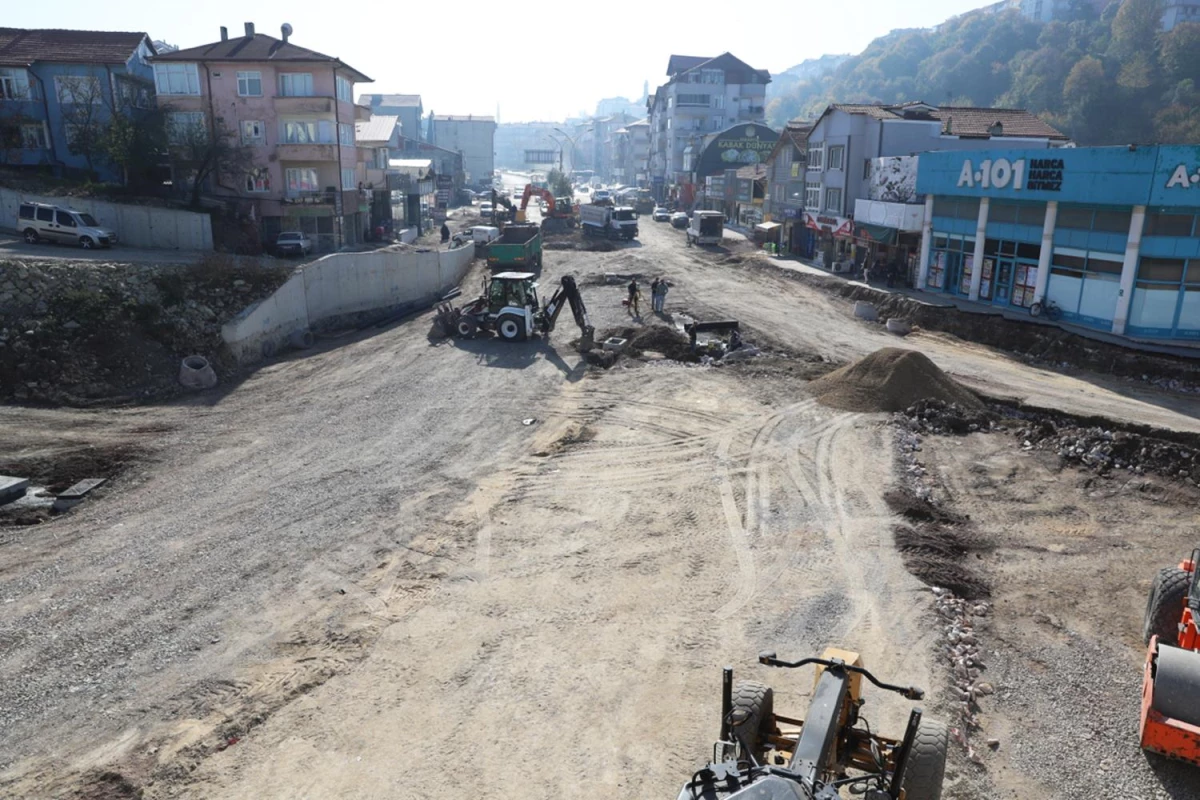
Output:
top-left (804, 102), bottom-right (1069, 272)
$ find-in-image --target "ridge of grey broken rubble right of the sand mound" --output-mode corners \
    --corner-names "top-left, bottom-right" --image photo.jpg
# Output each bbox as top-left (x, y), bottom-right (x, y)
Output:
top-left (1016, 417), bottom-right (1200, 485)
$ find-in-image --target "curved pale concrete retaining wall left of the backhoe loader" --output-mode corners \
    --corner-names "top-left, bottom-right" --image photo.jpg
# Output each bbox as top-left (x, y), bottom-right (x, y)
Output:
top-left (221, 247), bottom-right (474, 363)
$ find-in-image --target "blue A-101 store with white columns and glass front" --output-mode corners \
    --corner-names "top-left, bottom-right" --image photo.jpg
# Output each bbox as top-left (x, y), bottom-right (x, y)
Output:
top-left (917, 145), bottom-right (1200, 341)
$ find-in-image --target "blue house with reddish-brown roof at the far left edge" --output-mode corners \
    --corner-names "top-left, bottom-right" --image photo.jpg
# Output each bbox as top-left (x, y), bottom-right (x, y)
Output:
top-left (0, 28), bottom-right (155, 181)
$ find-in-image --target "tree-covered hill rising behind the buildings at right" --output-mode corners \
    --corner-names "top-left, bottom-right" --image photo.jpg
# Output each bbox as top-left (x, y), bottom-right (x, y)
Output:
top-left (767, 0), bottom-right (1200, 144)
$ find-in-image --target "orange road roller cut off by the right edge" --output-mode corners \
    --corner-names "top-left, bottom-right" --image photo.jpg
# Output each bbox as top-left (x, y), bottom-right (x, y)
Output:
top-left (1139, 549), bottom-right (1200, 766)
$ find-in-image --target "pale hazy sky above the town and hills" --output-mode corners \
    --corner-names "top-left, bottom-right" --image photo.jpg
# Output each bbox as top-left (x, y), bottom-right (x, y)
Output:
top-left (14, 0), bottom-right (986, 122)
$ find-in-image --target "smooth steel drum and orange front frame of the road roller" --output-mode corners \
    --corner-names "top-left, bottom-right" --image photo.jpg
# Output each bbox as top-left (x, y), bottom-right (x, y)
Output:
top-left (1139, 636), bottom-right (1200, 766)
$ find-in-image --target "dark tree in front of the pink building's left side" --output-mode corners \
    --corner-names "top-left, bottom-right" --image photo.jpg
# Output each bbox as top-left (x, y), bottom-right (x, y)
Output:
top-left (163, 110), bottom-right (254, 207)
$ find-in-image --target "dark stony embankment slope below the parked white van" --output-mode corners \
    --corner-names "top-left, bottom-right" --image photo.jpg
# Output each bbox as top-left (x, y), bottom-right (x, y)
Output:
top-left (0, 255), bottom-right (290, 405)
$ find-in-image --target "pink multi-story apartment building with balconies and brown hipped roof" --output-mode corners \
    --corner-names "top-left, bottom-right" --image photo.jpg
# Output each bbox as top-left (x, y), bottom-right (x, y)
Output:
top-left (151, 23), bottom-right (371, 249)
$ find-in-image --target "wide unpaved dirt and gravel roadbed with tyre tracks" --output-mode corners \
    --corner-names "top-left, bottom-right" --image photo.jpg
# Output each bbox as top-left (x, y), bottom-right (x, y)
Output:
top-left (0, 221), bottom-right (1200, 800)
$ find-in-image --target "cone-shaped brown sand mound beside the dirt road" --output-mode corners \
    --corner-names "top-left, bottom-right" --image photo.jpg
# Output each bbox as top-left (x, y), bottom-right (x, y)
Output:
top-left (809, 348), bottom-right (983, 411)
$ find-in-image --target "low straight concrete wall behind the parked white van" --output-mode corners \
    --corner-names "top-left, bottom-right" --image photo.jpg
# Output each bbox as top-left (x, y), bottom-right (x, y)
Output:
top-left (0, 188), bottom-right (212, 249)
